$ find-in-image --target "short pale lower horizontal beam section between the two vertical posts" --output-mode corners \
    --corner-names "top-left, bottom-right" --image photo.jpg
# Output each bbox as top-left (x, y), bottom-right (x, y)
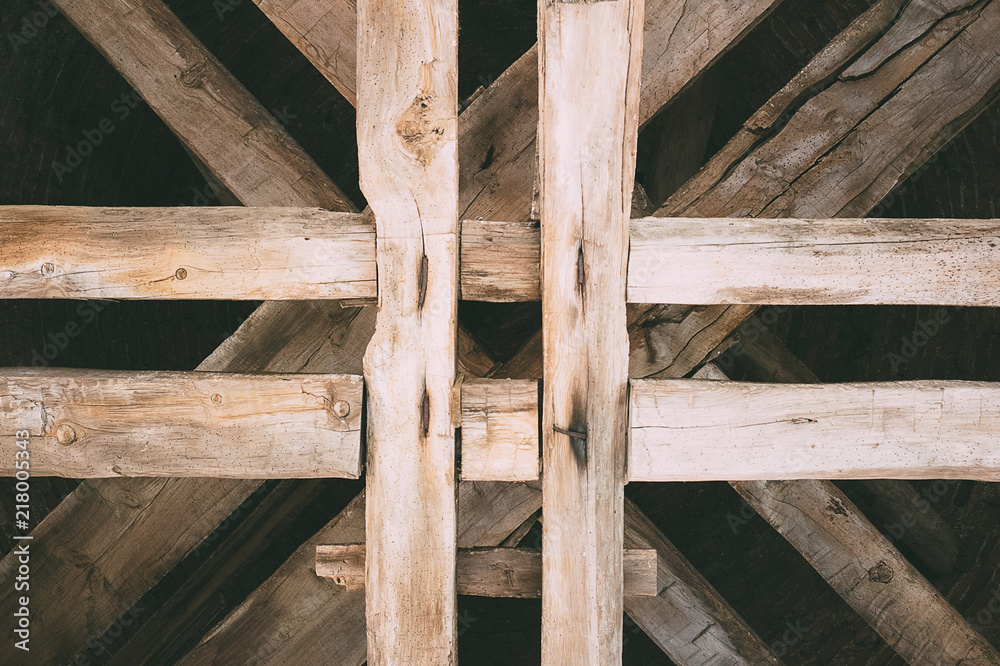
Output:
top-left (461, 379), bottom-right (539, 481)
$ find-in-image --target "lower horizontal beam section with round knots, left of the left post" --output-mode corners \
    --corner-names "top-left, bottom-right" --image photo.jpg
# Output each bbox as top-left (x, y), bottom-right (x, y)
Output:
top-left (0, 368), bottom-right (362, 479)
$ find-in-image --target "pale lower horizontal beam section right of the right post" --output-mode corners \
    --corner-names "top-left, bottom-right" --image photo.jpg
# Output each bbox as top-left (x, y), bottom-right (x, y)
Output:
top-left (629, 379), bottom-right (1000, 481)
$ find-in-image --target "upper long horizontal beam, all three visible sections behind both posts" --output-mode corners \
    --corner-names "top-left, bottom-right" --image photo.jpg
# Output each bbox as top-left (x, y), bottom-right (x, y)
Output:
top-left (7, 206), bottom-right (1000, 306)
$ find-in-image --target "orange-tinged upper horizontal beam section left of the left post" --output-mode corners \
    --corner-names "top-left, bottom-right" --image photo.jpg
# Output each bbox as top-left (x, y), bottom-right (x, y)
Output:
top-left (0, 206), bottom-right (376, 300)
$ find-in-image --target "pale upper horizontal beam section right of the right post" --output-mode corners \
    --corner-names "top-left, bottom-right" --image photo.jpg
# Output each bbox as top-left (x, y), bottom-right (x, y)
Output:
top-left (628, 218), bottom-right (1000, 307)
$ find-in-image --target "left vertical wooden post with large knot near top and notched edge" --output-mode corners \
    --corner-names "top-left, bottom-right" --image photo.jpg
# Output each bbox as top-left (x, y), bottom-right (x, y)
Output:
top-left (358, 0), bottom-right (458, 666)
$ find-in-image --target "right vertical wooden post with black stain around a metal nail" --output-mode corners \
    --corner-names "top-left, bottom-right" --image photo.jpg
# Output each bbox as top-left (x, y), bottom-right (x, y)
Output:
top-left (538, 0), bottom-right (643, 665)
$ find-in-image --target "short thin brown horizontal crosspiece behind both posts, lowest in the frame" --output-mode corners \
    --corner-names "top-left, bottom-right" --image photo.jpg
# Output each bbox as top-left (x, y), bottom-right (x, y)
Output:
top-left (316, 543), bottom-right (660, 599)
